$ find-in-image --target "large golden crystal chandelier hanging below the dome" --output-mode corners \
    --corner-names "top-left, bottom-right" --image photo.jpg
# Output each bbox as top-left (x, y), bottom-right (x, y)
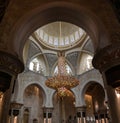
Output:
top-left (45, 52), bottom-right (79, 97)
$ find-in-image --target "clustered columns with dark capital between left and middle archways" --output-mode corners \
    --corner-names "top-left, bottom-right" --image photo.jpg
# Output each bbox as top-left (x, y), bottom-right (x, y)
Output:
top-left (43, 108), bottom-right (53, 123)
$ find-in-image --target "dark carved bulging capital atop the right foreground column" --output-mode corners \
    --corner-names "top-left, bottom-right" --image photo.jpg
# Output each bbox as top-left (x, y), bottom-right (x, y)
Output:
top-left (92, 43), bottom-right (120, 72)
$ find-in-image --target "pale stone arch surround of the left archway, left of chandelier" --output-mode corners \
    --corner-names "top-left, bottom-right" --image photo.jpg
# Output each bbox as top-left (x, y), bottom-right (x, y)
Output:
top-left (12, 71), bottom-right (54, 107)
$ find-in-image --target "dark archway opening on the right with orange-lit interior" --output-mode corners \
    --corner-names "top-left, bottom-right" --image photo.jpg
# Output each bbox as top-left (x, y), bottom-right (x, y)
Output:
top-left (84, 82), bottom-right (107, 120)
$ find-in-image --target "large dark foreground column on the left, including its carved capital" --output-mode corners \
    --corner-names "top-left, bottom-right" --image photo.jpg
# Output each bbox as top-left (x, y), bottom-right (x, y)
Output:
top-left (0, 51), bottom-right (24, 123)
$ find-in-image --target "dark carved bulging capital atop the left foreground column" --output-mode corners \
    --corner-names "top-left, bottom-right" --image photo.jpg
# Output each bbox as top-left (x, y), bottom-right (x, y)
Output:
top-left (0, 51), bottom-right (24, 75)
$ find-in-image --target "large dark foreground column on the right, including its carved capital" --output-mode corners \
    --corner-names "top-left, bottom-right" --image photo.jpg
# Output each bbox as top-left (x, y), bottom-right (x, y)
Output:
top-left (92, 43), bottom-right (120, 123)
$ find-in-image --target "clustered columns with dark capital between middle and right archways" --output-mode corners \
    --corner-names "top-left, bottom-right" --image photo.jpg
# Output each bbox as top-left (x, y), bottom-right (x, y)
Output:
top-left (76, 106), bottom-right (86, 123)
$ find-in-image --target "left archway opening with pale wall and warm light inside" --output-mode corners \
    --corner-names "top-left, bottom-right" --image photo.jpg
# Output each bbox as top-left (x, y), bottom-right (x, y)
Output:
top-left (23, 84), bottom-right (44, 122)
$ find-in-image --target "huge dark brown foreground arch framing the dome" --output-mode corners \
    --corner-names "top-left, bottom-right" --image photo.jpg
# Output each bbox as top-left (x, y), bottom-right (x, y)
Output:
top-left (10, 2), bottom-right (107, 59)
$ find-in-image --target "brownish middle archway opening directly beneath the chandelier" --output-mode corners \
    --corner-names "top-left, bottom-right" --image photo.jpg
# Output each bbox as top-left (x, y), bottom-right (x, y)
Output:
top-left (52, 90), bottom-right (76, 123)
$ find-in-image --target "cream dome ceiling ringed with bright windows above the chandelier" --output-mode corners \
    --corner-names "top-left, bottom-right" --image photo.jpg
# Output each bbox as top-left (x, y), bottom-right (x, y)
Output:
top-left (34, 21), bottom-right (86, 50)
